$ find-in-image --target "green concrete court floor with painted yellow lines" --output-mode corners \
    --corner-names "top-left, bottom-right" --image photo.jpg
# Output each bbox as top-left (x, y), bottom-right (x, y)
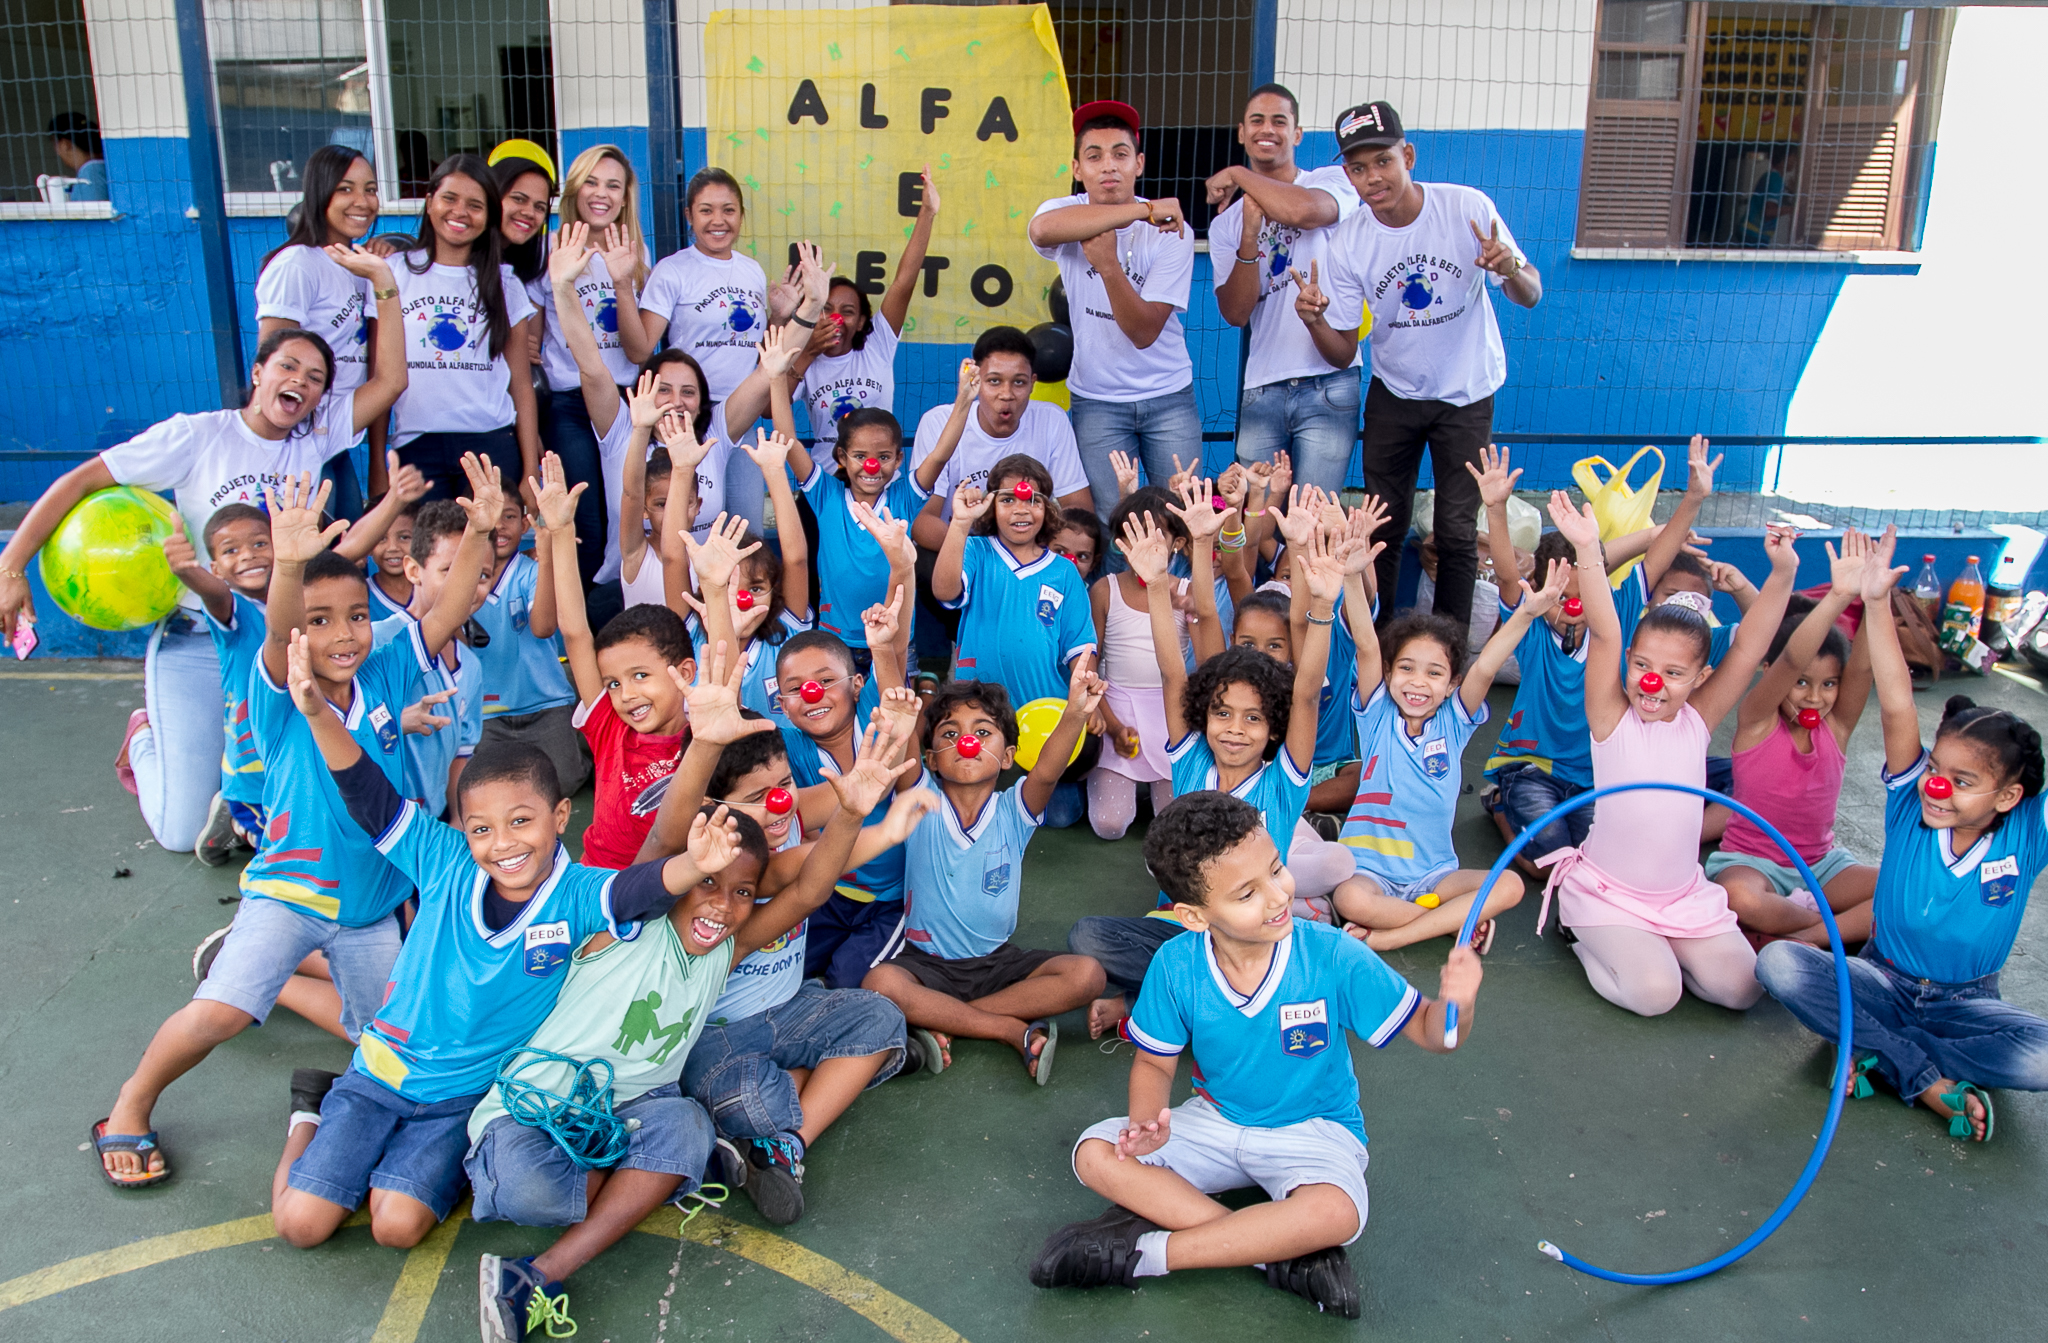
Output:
top-left (0, 663), bottom-right (2048, 1343)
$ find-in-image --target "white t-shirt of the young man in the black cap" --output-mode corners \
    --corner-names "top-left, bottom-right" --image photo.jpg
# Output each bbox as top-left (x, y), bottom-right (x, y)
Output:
top-left (1323, 182), bottom-right (1528, 405)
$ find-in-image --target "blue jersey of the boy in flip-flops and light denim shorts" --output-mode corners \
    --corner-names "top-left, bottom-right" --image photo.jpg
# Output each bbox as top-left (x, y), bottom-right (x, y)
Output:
top-left (242, 635), bottom-right (426, 927)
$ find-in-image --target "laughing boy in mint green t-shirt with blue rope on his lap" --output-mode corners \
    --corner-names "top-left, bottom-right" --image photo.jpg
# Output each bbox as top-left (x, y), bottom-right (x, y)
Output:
top-left (465, 646), bottom-right (911, 1341)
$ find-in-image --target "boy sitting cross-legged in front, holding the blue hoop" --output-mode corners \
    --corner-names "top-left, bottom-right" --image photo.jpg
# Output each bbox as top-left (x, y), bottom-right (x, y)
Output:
top-left (1030, 792), bottom-right (1481, 1318)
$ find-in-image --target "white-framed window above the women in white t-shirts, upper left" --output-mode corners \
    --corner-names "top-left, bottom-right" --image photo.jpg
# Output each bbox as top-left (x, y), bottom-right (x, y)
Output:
top-left (209, 0), bottom-right (559, 207)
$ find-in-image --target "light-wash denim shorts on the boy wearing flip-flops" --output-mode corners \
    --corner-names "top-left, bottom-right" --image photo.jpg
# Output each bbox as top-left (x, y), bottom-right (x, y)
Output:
top-left (193, 897), bottom-right (399, 1040)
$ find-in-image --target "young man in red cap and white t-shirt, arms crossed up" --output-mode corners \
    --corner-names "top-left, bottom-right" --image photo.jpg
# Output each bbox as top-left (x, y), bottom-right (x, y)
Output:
top-left (1030, 100), bottom-right (1202, 518)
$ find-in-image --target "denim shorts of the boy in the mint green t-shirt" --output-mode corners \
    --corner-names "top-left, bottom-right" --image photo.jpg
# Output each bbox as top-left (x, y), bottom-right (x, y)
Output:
top-left (463, 1083), bottom-right (717, 1226)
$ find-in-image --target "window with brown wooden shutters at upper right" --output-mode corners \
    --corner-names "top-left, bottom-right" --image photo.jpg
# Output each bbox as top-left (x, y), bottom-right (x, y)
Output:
top-left (1579, 0), bottom-right (1952, 252)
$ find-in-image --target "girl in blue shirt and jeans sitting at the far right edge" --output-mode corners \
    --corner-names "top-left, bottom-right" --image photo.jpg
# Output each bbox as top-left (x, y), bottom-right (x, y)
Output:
top-left (1757, 528), bottom-right (2048, 1142)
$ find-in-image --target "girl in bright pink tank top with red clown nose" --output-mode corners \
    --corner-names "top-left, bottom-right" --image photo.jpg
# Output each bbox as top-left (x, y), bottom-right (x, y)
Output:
top-left (1706, 528), bottom-right (1878, 946)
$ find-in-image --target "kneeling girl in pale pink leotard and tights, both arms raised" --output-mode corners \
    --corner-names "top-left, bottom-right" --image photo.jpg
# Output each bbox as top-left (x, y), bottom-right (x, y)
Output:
top-left (1518, 491), bottom-right (1798, 1017)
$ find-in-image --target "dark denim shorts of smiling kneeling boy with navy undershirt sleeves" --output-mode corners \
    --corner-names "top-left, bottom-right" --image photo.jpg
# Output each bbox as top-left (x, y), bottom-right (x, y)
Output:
top-left (285, 1067), bottom-right (483, 1218)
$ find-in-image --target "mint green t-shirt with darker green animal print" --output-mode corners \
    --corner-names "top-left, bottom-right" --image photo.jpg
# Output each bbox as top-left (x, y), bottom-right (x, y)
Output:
top-left (469, 917), bottom-right (733, 1142)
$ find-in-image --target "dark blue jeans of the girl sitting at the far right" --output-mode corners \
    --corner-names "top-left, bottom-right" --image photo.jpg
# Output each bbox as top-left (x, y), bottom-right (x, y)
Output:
top-left (1757, 942), bottom-right (2048, 1101)
